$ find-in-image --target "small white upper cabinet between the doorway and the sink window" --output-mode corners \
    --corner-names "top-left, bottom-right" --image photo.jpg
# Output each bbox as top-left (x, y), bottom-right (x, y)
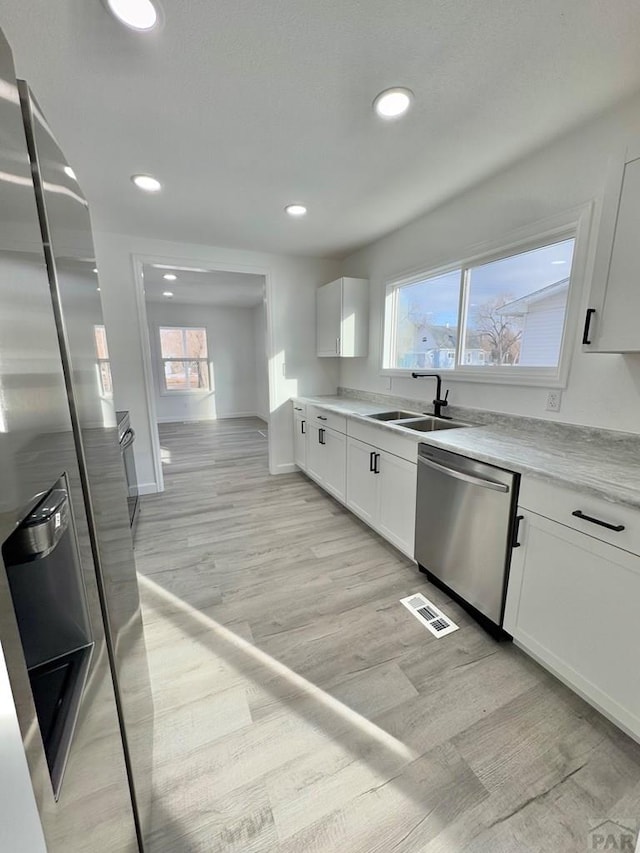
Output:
top-left (316, 278), bottom-right (369, 358)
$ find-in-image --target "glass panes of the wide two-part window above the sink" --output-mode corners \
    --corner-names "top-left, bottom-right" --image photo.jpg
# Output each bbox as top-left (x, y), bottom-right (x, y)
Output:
top-left (383, 235), bottom-right (575, 377)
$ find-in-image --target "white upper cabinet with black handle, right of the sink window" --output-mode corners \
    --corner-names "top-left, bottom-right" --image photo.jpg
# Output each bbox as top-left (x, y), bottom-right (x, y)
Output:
top-left (582, 145), bottom-right (640, 353)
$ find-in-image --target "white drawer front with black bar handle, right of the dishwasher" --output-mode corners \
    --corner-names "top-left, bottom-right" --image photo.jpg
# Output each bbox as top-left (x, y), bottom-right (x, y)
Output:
top-left (518, 477), bottom-right (640, 555)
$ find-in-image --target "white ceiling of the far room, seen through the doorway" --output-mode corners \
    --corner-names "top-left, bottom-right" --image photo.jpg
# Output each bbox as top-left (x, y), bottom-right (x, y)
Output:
top-left (143, 264), bottom-right (264, 308)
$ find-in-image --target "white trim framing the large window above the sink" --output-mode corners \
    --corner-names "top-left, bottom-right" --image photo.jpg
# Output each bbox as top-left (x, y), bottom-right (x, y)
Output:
top-left (379, 202), bottom-right (593, 388)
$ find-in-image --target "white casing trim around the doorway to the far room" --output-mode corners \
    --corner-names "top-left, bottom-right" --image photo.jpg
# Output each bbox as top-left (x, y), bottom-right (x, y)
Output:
top-left (131, 253), bottom-right (274, 492)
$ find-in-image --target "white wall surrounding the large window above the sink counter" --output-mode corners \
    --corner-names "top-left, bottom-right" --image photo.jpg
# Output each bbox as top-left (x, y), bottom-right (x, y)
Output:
top-left (340, 91), bottom-right (640, 432)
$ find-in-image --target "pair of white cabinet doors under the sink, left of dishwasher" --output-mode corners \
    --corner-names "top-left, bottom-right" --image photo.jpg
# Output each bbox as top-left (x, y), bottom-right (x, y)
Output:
top-left (347, 438), bottom-right (417, 559)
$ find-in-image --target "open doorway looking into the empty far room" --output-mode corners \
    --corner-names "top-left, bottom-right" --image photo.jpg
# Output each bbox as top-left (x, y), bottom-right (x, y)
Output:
top-left (140, 261), bottom-right (270, 490)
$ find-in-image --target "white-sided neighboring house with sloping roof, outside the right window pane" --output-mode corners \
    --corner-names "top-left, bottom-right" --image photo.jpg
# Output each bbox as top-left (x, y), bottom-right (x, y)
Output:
top-left (496, 278), bottom-right (569, 367)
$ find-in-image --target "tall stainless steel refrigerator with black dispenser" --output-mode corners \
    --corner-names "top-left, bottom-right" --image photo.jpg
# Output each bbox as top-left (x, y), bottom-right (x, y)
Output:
top-left (0, 26), bottom-right (153, 853)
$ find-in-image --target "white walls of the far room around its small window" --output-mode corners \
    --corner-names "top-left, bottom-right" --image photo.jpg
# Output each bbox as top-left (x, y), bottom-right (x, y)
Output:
top-left (147, 300), bottom-right (268, 423)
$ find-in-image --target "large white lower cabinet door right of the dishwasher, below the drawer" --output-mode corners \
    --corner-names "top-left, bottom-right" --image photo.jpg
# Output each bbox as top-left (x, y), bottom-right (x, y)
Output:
top-left (504, 511), bottom-right (640, 738)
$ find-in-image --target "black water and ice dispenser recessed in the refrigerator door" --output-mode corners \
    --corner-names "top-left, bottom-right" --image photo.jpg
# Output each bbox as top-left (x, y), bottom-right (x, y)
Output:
top-left (2, 475), bottom-right (94, 800)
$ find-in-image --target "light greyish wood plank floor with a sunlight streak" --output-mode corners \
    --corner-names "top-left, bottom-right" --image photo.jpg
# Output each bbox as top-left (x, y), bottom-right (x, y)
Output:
top-left (136, 419), bottom-right (640, 853)
